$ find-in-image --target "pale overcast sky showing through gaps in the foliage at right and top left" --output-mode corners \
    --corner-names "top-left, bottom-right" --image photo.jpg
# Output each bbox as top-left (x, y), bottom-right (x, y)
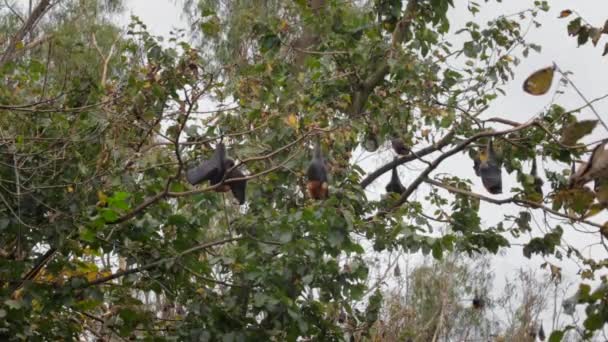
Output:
top-left (123, 0), bottom-right (608, 332)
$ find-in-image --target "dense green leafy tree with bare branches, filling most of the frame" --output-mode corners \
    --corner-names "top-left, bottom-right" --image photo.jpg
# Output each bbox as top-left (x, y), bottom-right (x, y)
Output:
top-left (0, 0), bottom-right (608, 341)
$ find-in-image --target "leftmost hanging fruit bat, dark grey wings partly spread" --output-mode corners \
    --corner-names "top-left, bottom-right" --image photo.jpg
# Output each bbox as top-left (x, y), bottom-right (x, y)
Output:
top-left (186, 143), bottom-right (247, 204)
